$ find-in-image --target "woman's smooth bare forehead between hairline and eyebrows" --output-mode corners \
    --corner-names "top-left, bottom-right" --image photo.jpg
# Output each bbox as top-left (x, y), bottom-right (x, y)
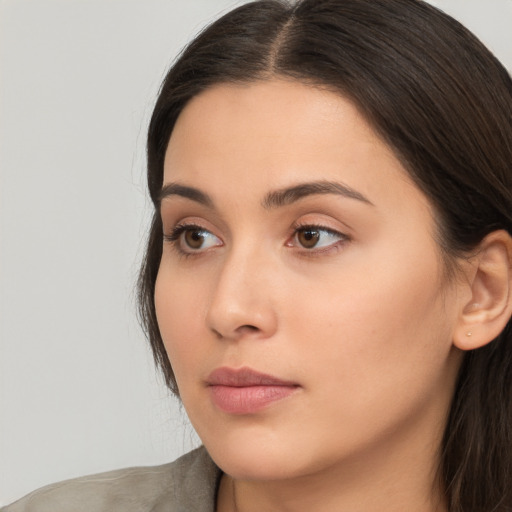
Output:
top-left (164, 80), bottom-right (424, 214)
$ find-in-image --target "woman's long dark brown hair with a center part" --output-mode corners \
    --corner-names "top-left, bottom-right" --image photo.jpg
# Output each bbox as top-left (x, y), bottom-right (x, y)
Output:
top-left (139, 0), bottom-right (512, 512)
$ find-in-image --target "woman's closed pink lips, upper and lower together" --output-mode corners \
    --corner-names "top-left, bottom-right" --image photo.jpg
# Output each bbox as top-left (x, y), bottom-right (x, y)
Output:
top-left (206, 367), bottom-right (300, 415)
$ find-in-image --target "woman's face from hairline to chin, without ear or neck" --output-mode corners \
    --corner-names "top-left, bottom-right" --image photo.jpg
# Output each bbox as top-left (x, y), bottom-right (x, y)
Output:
top-left (155, 80), bottom-right (461, 479)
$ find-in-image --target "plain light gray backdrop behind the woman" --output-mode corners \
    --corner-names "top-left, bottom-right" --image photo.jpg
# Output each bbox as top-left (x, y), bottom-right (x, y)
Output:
top-left (0, 0), bottom-right (512, 505)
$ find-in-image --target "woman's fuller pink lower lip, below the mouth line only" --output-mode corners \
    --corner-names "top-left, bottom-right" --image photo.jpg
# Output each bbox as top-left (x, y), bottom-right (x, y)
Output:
top-left (209, 385), bottom-right (298, 414)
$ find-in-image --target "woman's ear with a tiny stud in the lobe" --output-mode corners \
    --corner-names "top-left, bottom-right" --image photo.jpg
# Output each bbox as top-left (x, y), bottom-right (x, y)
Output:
top-left (453, 230), bottom-right (512, 350)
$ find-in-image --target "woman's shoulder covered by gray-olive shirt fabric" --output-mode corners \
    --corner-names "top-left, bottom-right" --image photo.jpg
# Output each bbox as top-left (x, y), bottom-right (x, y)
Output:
top-left (1, 447), bottom-right (220, 512)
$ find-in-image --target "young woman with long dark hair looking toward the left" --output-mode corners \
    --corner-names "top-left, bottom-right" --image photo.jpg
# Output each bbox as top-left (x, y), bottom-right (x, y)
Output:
top-left (6, 0), bottom-right (512, 512)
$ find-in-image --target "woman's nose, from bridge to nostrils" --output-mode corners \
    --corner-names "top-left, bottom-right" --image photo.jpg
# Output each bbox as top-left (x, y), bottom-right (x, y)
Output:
top-left (206, 246), bottom-right (277, 340)
